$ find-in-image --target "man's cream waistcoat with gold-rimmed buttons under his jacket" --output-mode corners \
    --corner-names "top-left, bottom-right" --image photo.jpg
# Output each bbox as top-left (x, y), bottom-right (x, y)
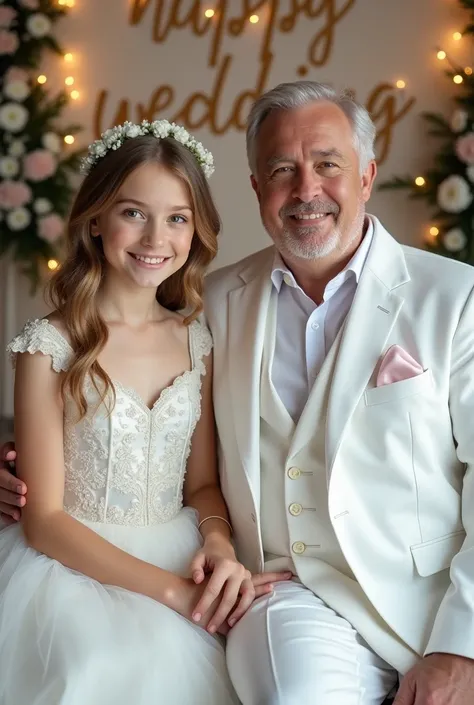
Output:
top-left (260, 291), bottom-right (414, 672)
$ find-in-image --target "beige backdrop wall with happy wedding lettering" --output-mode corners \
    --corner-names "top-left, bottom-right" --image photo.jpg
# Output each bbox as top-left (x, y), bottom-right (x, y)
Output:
top-left (2, 0), bottom-right (462, 416)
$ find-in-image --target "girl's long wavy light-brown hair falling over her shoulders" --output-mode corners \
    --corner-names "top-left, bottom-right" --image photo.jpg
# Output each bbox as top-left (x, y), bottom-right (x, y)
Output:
top-left (47, 135), bottom-right (221, 419)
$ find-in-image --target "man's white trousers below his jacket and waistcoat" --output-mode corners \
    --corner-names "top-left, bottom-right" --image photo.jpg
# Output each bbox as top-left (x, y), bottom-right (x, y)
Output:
top-left (227, 582), bottom-right (398, 705)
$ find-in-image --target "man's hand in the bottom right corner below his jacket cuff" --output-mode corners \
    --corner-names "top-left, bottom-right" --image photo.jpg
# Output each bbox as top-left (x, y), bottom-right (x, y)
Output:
top-left (393, 654), bottom-right (474, 705)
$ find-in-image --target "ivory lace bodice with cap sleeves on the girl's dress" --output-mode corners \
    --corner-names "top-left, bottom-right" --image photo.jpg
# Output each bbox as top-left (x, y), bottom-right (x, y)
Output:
top-left (7, 319), bottom-right (212, 526)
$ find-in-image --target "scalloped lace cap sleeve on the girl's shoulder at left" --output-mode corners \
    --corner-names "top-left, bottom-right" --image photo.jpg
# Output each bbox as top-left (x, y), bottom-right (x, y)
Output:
top-left (7, 318), bottom-right (73, 372)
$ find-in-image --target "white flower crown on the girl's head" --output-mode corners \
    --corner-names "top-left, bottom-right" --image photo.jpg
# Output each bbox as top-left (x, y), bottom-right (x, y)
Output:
top-left (81, 120), bottom-right (214, 178)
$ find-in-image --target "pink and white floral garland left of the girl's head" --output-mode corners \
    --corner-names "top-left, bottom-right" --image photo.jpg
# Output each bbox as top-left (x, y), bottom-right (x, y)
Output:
top-left (0, 0), bottom-right (82, 288)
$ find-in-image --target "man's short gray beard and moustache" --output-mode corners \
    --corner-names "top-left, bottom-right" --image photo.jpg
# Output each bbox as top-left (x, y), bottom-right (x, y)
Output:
top-left (269, 200), bottom-right (365, 260)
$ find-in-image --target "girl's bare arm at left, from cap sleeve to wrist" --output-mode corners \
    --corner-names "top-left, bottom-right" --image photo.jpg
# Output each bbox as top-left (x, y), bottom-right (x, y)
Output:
top-left (15, 353), bottom-right (183, 606)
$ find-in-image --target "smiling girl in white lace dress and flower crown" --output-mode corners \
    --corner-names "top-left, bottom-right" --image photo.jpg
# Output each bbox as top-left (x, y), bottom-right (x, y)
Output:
top-left (0, 121), bottom-right (286, 705)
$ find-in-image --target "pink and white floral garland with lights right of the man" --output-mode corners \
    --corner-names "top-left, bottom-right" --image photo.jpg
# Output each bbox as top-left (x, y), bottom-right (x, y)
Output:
top-left (380, 0), bottom-right (474, 264)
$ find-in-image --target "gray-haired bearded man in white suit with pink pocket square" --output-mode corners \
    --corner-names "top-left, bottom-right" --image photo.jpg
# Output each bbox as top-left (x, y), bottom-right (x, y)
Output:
top-left (0, 82), bottom-right (474, 705)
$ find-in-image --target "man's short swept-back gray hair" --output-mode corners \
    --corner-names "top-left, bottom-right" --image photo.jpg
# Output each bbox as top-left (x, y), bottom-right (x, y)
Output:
top-left (247, 81), bottom-right (376, 175)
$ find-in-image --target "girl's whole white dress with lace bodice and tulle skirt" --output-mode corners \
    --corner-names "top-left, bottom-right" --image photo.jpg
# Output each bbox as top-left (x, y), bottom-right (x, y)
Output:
top-left (0, 320), bottom-right (238, 705)
